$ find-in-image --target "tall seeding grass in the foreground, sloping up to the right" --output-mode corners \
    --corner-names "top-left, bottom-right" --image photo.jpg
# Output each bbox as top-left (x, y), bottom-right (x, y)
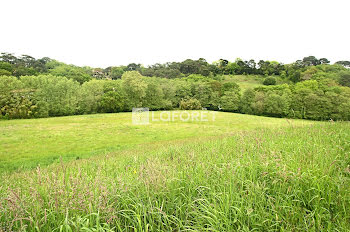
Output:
top-left (0, 123), bottom-right (350, 231)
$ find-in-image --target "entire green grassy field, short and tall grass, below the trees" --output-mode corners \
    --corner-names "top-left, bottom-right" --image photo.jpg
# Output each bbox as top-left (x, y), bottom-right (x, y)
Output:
top-left (0, 112), bottom-right (350, 231)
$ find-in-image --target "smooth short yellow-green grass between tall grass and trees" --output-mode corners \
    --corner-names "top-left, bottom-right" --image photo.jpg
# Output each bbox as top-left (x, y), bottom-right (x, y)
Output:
top-left (0, 111), bottom-right (315, 172)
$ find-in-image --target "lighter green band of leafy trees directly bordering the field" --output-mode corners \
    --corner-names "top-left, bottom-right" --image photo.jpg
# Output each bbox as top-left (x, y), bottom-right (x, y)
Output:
top-left (0, 71), bottom-right (350, 120)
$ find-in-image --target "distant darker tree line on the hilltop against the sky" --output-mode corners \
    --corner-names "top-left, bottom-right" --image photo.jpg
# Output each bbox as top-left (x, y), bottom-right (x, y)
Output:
top-left (0, 53), bottom-right (350, 84)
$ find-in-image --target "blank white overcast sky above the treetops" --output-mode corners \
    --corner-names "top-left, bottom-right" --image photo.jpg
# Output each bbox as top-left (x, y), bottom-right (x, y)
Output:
top-left (0, 0), bottom-right (350, 68)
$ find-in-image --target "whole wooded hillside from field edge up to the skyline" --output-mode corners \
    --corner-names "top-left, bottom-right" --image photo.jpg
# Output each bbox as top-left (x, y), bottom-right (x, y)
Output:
top-left (0, 53), bottom-right (350, 120)
